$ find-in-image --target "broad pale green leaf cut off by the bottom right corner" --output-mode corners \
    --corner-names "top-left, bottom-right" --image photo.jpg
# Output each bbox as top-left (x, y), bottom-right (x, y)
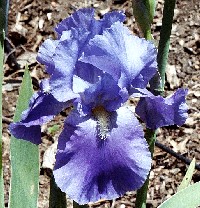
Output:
top-left (158, 182), bottom-right (200, 208)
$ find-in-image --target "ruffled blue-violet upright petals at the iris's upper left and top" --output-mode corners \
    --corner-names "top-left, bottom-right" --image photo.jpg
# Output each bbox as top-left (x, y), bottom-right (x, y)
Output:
top-left (37, 8), bottom-right (125, 99)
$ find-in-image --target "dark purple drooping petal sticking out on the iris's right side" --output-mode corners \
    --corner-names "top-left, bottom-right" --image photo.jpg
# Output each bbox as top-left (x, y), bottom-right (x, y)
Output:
top-left (135, 89), bottom-right (188, 129)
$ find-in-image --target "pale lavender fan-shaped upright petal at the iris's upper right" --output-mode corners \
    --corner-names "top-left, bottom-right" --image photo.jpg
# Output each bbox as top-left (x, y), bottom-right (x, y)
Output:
top-left (80, 22), bottom-right (157, 88)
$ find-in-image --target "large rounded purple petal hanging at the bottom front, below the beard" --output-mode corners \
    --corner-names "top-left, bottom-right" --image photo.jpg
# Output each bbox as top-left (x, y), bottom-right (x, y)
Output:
top-left (54, 107), bottom-right (151, 204)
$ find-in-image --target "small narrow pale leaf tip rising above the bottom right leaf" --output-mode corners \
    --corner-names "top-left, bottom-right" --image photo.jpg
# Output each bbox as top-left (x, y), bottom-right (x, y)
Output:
top-left (177, 158), bottom-right (195, 192)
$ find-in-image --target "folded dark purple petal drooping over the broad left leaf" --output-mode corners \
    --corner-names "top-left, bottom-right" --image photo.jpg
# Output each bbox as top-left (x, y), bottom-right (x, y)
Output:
top-left (10, 80), bottom-right (71, 144)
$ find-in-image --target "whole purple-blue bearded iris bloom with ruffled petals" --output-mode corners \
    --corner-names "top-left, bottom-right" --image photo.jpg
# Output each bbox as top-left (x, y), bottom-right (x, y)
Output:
top-left (10, 9), bottom-right (187, 204)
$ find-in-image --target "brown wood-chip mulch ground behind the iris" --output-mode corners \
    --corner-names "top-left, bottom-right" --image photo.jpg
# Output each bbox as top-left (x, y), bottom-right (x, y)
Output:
top-left (3, 0), bottom-right (200, 208)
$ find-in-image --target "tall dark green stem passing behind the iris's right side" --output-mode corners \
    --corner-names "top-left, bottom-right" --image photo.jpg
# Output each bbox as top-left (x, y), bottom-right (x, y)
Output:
top-left (135, 0), bottom-right (176, 208)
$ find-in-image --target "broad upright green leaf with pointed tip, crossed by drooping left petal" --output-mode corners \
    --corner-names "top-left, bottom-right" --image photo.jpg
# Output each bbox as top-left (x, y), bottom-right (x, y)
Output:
top-left (9, 67), bottom-right (39, 208)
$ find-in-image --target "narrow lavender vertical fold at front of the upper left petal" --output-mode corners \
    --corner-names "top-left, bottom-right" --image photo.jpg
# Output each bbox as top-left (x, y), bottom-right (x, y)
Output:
top-left (50, 32), bottom-right (79, 102)
